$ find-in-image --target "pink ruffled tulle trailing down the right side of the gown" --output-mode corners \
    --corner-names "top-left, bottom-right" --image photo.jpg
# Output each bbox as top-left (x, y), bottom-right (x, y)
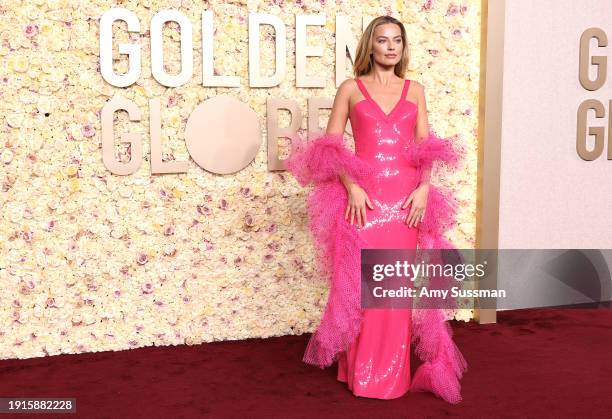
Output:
top-left (407, 131), bottom-right (467, 403)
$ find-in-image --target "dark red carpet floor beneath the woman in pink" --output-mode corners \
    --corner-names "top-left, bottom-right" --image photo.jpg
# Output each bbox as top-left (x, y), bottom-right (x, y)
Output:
top-left (0, 309), bottom-right (612, 418)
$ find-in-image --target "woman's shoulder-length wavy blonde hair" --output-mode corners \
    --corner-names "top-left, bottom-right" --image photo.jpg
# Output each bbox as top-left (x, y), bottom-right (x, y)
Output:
top-left (353, 16), bottom-right (409, 79)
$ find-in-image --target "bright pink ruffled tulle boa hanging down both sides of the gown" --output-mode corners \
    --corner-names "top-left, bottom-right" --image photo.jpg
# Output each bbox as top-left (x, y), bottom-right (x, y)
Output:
top-left (284, 131), bottom-right (467, 403)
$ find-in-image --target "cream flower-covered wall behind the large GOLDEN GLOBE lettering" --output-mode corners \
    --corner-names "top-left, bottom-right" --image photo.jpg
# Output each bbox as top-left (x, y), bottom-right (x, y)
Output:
top-left (0, 0), bottom-right (480, 358)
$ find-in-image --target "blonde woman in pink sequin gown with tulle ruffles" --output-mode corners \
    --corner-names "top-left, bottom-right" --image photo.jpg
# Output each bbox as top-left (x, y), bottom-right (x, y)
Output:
top-left (285, 16), bottom-right (467, 403)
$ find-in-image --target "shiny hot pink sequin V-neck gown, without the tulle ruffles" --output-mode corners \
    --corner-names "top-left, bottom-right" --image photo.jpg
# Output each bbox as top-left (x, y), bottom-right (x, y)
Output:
top-left (337, 79), bottom-right (419, 399)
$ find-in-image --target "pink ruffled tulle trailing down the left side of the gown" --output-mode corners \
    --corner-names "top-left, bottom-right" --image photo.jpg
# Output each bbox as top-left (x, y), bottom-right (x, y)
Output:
top-left (284, 132), bottom-right (374, 368)
